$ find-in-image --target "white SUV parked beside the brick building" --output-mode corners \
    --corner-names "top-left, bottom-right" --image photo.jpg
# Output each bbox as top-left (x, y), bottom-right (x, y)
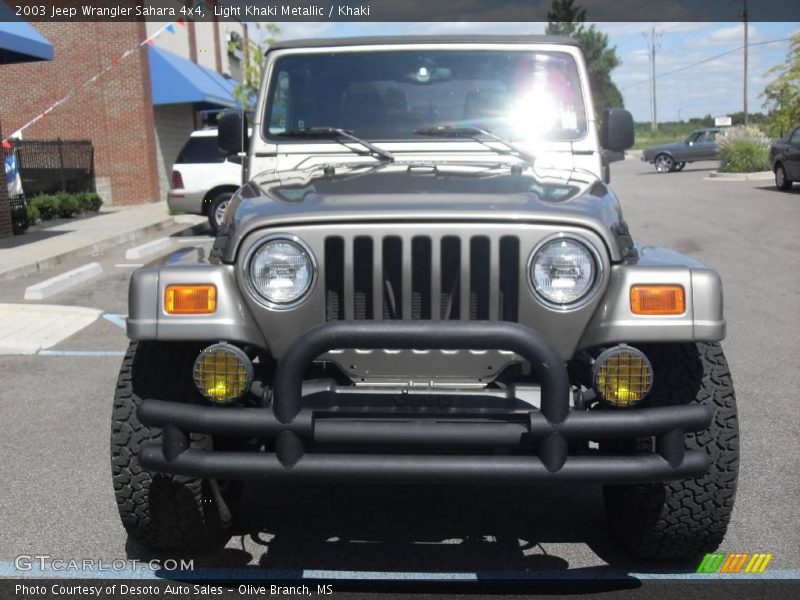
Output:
top-left (167, 128), bottom-right (242, 233)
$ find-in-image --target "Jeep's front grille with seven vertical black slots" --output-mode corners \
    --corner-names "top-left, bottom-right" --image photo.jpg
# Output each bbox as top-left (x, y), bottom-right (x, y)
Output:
top-left (322, 235), bottom-right (520, 321)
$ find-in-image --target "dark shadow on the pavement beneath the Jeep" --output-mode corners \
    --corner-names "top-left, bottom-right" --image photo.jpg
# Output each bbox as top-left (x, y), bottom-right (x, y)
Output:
top-left (127, 484), bottom-right (697, 593)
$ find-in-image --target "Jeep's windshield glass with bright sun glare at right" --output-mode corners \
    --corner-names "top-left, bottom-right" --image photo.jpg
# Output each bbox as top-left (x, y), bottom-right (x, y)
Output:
top-left (264, 50), bottom-right (586, 142)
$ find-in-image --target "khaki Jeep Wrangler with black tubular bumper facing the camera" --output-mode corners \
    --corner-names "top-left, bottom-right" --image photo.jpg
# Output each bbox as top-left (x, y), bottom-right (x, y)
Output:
top-left (111, 36), bottom-right (738, 557)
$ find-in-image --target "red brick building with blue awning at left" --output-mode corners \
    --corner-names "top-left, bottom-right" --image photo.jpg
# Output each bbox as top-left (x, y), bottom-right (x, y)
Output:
top-left (0, 22), bottom-right (247, 216)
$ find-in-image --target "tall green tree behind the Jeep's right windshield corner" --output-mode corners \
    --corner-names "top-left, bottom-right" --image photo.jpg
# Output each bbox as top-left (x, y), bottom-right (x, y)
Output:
top-left (545, 0), bottom-right (625, 115)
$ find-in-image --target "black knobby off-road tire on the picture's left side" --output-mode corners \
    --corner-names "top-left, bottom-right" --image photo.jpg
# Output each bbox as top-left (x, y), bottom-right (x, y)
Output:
top-left (111, 342), bottom-right (230, 551)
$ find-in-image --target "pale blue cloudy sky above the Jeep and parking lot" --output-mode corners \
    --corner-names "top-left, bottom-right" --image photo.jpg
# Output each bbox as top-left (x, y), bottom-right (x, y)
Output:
top-left (264, 22), bottom-right (800, 122)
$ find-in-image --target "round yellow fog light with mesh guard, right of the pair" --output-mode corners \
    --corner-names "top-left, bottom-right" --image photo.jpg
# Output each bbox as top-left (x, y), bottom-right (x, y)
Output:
top-left (593, 346), bottom-right (653, 407)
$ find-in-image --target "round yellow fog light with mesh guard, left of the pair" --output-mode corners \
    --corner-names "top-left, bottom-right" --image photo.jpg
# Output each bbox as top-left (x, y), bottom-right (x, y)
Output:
top-left (193, 342), bottom-right (253, 404)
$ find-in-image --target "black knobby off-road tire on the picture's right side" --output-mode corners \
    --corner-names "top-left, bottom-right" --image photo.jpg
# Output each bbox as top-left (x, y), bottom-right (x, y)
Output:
top-left (603, 343), bottom-right (739, 559)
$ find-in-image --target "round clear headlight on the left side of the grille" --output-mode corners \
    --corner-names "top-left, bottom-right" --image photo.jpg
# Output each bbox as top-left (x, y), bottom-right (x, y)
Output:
top-left (249, 238), bottom-right (314, 306)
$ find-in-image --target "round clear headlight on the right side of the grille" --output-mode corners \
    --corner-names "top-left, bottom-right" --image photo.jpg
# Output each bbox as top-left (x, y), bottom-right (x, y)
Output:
top-left (530, 237), bottom-right (597, 306)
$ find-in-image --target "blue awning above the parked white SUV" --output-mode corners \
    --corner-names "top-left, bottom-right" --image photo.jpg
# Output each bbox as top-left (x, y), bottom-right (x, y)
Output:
top-left (147, 46), bottom-right (239, 108)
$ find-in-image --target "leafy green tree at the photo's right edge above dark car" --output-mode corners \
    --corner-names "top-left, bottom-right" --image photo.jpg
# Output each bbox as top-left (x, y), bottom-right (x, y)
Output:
top-left (761, 33), bottom-right (800, 137)
